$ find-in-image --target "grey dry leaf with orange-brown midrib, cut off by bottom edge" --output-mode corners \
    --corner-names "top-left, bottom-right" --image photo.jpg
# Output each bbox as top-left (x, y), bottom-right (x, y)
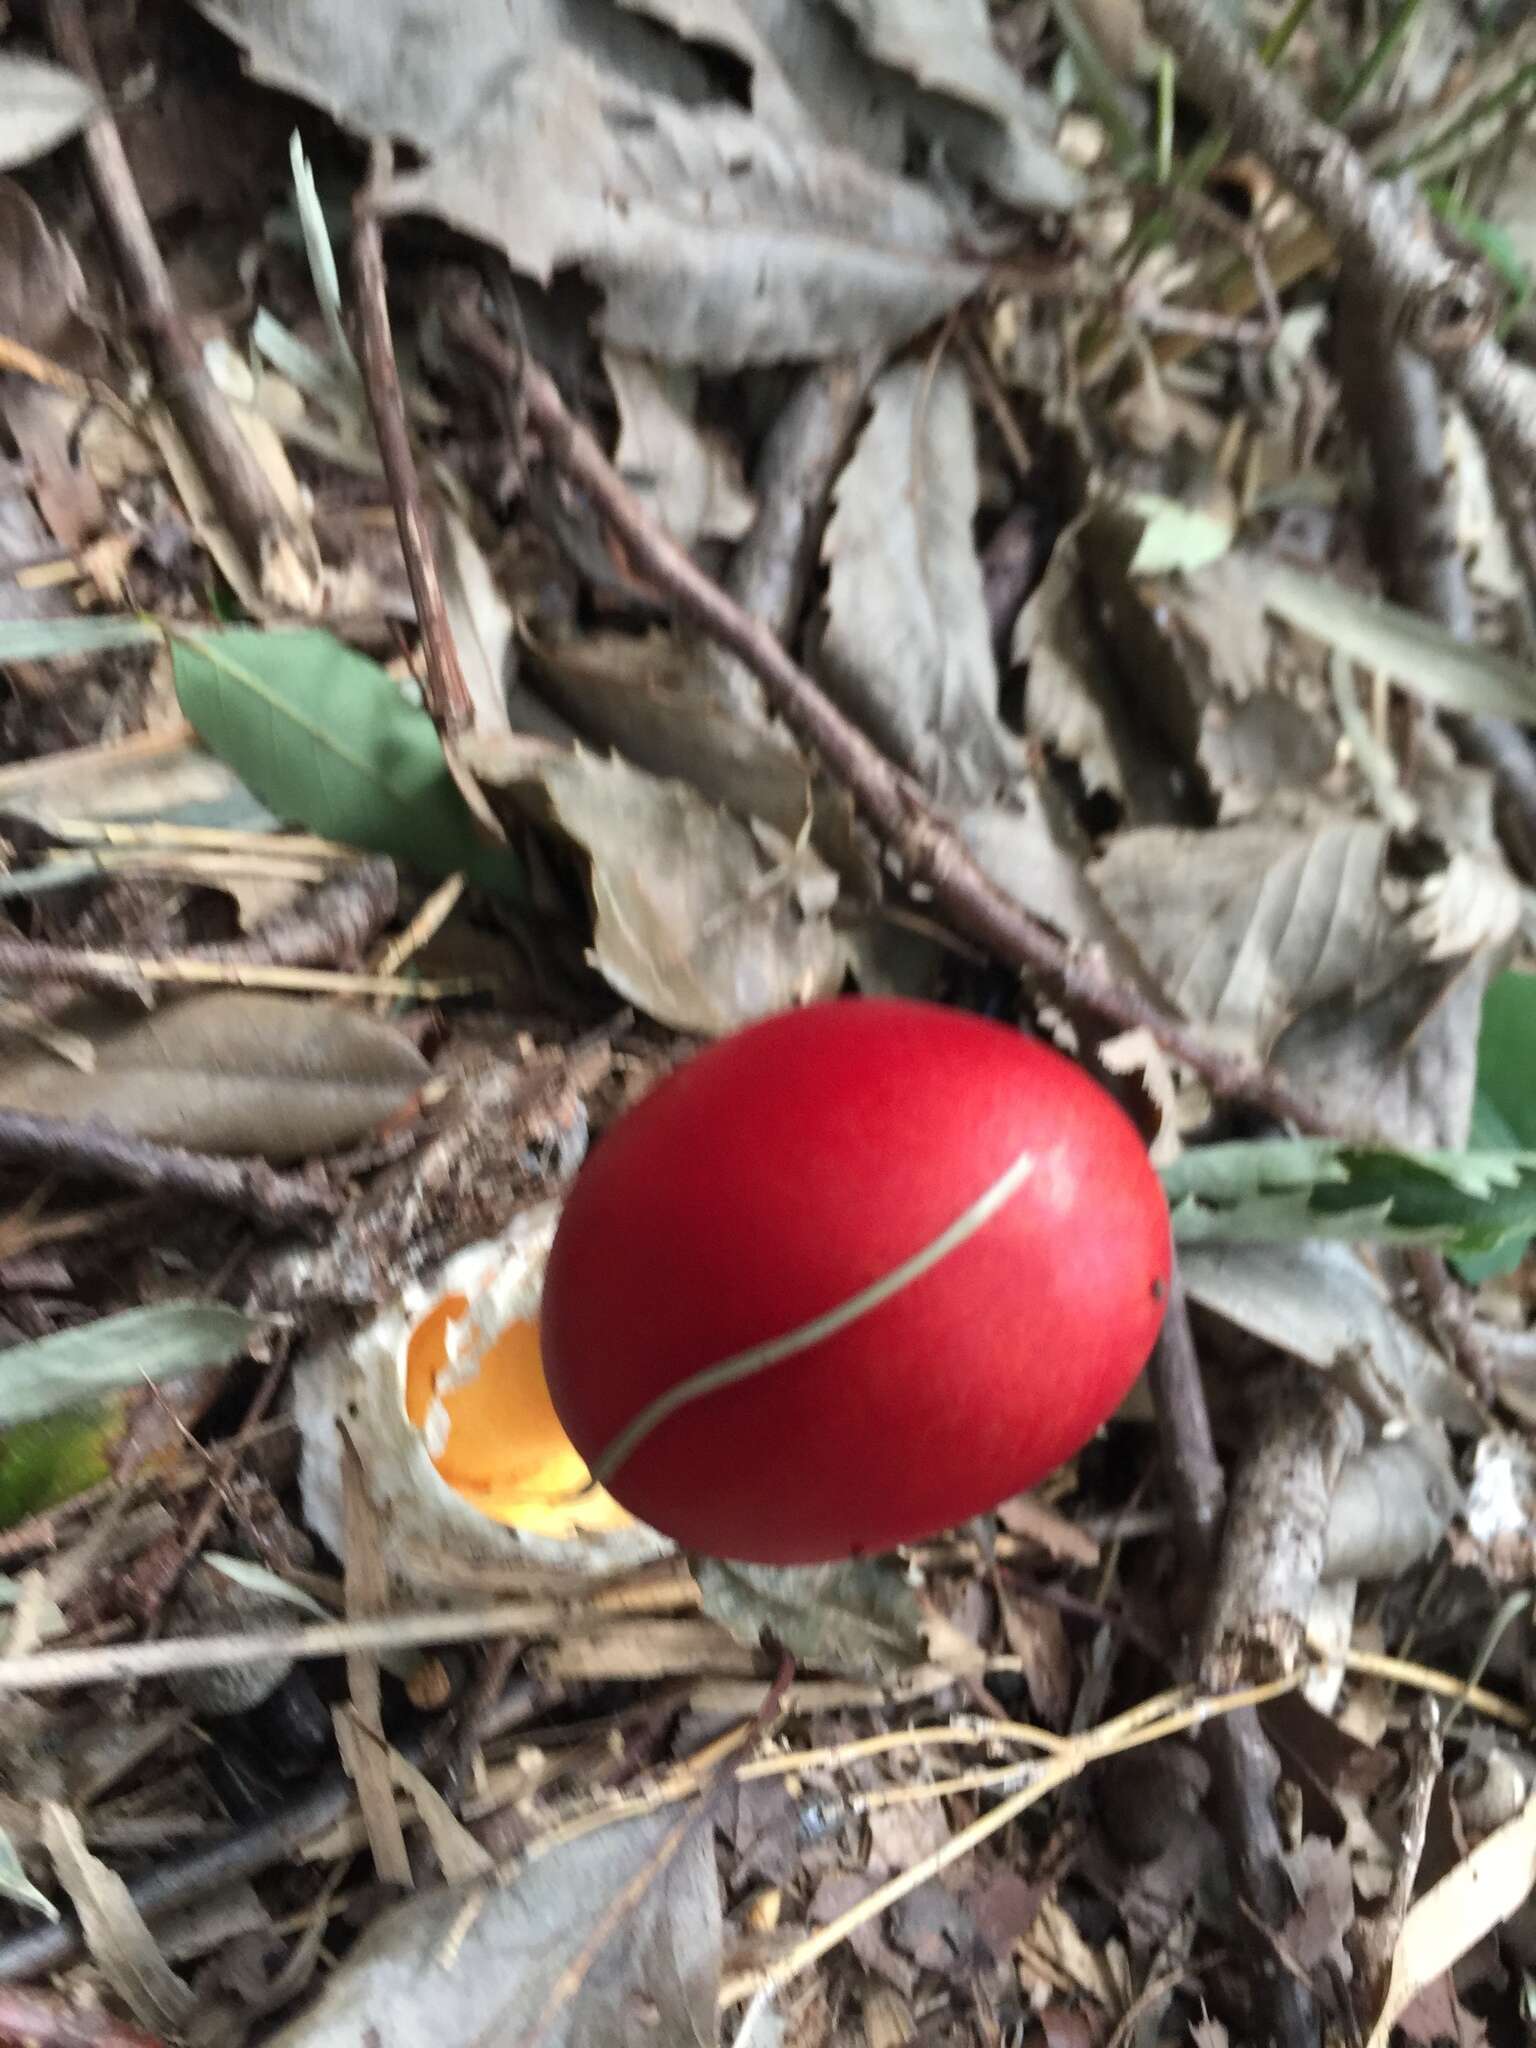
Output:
top-left (272, 1808), bottom-right (721, 2048)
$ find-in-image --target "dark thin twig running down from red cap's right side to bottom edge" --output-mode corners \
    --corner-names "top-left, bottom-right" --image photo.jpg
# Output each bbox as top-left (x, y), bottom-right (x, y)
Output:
top-left (1149, 1272), bottom-right (1319, 2048)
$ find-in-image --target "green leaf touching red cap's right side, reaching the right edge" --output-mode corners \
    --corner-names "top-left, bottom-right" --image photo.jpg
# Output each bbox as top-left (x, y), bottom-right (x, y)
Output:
top-left (1163, 1139), bottom-right (1536, 1253)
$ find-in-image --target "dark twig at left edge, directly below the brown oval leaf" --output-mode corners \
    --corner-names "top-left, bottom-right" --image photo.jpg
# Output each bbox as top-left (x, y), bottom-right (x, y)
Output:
top-left (0, 1110), bottom-right (340, 1225)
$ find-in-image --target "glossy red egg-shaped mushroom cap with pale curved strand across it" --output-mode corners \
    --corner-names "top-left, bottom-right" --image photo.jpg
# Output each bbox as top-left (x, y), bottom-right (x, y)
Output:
top-left (543, 999), bottom-right (1169, 1563)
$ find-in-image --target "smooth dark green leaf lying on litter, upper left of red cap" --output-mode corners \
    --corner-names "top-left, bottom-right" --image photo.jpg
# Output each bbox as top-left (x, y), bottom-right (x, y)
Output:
top-left (172, 627), bottom-right (522, 897)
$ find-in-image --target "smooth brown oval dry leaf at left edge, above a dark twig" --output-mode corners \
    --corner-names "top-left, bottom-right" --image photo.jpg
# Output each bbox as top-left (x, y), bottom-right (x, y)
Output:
top-left (0, 989), bottom-right (428, 1159)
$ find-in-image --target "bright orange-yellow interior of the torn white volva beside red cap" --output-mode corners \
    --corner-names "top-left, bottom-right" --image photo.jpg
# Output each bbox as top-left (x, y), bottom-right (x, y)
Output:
top-left (406, 1294), bottom-right (631, 1536)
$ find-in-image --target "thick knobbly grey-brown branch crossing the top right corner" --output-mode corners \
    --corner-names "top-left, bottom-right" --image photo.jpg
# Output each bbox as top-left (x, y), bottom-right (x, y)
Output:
top-left (1147, 0), bottom-right (1536, 473)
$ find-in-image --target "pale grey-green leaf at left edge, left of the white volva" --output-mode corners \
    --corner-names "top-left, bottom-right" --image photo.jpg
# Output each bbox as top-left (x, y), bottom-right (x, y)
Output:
top-left (0, 1300), bottom-right (262, 1433)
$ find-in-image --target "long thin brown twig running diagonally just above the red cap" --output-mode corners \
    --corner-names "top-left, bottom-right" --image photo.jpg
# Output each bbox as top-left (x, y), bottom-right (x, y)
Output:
top-left (449, 295), bottom-right (1327, 1130)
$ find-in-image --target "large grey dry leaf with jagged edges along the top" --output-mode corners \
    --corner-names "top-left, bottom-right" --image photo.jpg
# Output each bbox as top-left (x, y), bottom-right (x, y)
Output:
top-left (203, 0), bottom-right (979, 369)
